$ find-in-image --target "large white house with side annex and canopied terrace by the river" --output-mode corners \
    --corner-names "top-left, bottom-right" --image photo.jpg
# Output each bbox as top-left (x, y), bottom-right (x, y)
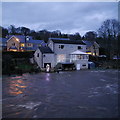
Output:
top-left (34, 38), bottom-right (89, 69)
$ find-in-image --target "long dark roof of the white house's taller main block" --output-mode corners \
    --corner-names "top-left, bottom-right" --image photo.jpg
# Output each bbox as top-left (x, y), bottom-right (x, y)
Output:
top-left (51, 39), bottom-right (85, 45)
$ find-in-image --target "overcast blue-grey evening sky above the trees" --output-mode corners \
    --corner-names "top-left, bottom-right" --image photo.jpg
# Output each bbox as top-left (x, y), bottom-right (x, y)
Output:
top-left (2, 2), bottom-right (118, 35)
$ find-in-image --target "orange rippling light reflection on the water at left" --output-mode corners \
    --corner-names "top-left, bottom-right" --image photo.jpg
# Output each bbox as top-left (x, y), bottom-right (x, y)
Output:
top-left (8, 76), bottom-right (27, 95)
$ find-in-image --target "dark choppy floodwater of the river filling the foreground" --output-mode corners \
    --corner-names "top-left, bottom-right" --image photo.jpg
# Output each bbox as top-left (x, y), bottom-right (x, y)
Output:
top-left (2, 70), bottom-right (118, 118)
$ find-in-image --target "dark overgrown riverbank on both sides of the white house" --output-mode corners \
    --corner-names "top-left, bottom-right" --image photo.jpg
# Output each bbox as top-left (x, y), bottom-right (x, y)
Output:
top-left (2, 51), bottom-right (120, 75)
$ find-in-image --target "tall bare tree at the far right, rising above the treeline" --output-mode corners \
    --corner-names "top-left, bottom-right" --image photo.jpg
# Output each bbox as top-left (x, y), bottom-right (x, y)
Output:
top-left (98, 19), bottom-right (120, 58)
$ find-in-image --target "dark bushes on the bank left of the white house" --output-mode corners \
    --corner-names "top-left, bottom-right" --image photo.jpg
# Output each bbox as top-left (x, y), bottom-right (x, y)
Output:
top-left (2, 52), bottom-right (39, 75)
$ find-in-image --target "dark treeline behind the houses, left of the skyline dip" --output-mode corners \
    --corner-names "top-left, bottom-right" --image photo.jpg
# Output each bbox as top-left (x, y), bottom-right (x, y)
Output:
top-left (0, 25), bottom-right (81, 42)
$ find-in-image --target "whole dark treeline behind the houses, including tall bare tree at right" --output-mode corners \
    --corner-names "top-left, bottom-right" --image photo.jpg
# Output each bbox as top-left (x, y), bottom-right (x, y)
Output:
top-left (0, 19), bottom-right (120, 58)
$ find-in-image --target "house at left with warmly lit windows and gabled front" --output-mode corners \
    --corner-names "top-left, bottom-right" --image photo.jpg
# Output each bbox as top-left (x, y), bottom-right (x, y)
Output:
top-left (6, 35), bottom-right (46, 51)
